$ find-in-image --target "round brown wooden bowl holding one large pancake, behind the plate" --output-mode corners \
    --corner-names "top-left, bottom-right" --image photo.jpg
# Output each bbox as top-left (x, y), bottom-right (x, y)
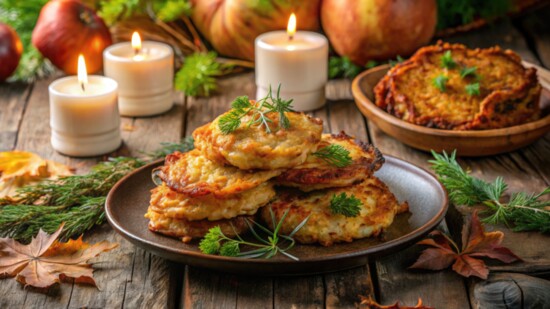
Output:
top-left (351, 65), bottom-right (550, 157)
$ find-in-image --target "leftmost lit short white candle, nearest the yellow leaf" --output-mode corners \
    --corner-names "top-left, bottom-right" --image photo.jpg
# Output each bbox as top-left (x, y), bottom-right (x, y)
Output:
top-left (49, 55), bottom-right (121, 157)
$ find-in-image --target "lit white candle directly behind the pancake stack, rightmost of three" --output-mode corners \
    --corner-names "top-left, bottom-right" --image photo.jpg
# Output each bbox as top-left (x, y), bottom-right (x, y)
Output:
top-left (255, 14), bottom-right (328, 111)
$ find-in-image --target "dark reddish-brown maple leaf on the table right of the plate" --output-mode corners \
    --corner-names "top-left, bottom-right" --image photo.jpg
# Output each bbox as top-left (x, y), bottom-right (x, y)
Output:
top-left (409, 211), bottom-right (521, 279)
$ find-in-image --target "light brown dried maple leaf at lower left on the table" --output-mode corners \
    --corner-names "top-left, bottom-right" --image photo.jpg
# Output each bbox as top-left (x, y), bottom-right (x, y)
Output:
top-left (0, 225), bottom-right (118, 289)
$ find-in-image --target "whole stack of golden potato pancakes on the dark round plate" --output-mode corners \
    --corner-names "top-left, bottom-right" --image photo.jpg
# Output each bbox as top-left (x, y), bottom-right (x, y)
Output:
top-left (145, 101), bottom-right (406, 246)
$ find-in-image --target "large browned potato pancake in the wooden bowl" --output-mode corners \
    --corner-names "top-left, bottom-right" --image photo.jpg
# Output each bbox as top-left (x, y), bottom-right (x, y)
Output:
top-left (374, 42), bottom-right (541, 130)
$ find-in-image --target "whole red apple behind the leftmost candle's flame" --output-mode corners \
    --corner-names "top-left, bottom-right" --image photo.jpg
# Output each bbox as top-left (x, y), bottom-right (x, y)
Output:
top-left (32, 0), bottom-right (113, 74)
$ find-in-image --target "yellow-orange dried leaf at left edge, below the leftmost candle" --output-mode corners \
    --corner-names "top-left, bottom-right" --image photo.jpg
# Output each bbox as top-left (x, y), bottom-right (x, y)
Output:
top-left (0, 151), bottom-right (72, 198)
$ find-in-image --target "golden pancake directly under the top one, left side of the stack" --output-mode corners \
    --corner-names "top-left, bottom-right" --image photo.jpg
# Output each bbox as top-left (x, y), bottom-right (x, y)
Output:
top-left (157, 149), bottom-right (283, 198)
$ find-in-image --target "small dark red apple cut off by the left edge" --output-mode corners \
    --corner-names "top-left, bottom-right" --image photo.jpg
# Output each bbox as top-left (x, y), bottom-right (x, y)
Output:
top-left (0, 23), bottom-right (23, 82)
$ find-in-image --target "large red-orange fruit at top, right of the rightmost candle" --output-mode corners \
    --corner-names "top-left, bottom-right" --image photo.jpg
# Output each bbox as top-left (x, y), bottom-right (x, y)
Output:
top-left (321, 0), bottom-right (437, 65)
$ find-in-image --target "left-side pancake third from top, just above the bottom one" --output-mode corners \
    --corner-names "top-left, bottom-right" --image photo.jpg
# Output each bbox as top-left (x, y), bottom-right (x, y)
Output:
top-left (150, 182), bottom-right (275, 221)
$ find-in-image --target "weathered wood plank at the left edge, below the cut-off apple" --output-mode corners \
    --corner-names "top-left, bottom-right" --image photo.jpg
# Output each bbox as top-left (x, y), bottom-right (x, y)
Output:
top-left (0, 83), bottom-right (32, 151)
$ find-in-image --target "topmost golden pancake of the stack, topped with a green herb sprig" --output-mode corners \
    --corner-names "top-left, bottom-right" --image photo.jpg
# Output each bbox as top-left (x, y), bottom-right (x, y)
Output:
top-left (193, 108), bottom-right (323, 170)
